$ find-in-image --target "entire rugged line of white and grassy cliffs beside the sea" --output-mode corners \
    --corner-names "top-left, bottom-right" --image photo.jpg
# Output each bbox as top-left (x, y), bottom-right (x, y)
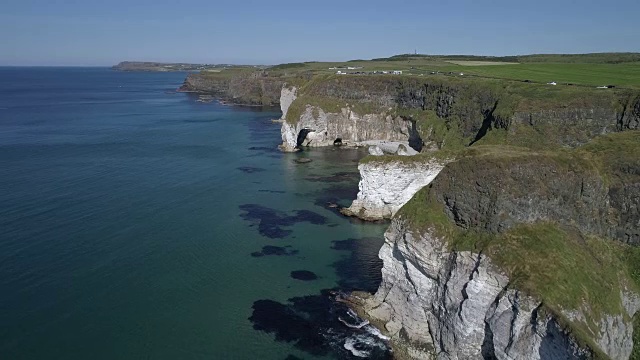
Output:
top-left (183, 67), bottom-right (640, 359)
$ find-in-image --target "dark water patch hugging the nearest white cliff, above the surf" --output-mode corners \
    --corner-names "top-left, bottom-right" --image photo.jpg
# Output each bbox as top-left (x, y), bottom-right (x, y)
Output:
top-left (331, 237), bottom-right (384, 293)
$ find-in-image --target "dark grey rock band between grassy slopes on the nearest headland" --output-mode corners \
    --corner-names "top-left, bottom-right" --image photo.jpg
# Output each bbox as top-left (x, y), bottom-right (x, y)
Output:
top-left (433, 146), bottom-right (640, 244)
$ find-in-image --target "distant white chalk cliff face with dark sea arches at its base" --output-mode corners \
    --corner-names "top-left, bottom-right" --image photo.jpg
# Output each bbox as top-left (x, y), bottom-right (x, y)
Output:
top-left (280, 106), bottom-right (412, 151)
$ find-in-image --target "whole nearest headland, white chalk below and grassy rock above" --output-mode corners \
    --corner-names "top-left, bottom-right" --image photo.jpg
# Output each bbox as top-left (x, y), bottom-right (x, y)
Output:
top-left (361, 131), bottom-right (640, 359)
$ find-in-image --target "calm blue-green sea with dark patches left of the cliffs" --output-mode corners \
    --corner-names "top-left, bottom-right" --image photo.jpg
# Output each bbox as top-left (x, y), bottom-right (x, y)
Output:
top-left (0, 68), bottom-right (386, 359)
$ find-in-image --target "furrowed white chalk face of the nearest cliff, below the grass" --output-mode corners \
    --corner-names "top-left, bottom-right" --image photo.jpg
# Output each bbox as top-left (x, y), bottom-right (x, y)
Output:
top-left (364, 218), bottom-right (639, 360)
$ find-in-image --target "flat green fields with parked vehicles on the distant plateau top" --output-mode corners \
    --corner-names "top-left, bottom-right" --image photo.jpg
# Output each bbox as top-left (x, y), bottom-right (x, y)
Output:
top-left (262, 54), bottom-right (640, 91)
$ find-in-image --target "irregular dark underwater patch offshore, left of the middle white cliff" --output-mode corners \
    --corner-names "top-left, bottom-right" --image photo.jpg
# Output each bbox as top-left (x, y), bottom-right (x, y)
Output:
top-left (239, 204), bottom-right (327, 239)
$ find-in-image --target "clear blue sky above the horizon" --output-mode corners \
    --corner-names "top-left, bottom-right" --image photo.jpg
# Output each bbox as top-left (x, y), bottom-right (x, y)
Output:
top-left (0, 0), bottom-right (640, 65)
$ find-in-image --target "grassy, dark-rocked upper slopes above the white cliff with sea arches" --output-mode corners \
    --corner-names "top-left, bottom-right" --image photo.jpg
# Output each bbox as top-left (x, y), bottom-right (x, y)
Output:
top-left (287, 75), bottom-right (640, 149)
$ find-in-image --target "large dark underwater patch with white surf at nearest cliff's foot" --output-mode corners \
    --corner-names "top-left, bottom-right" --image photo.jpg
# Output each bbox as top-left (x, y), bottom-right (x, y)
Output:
top-left (249, 290), bottom-right (392, 359)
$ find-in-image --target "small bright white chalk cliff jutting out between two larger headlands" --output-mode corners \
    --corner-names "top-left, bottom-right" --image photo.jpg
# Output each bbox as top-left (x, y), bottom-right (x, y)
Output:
top-left (342, 158), bottom-right (448, 220)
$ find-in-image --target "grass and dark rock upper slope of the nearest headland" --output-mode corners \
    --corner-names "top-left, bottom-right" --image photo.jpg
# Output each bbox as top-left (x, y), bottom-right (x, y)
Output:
top-left (397, 131), bottom-right (640, 358)
